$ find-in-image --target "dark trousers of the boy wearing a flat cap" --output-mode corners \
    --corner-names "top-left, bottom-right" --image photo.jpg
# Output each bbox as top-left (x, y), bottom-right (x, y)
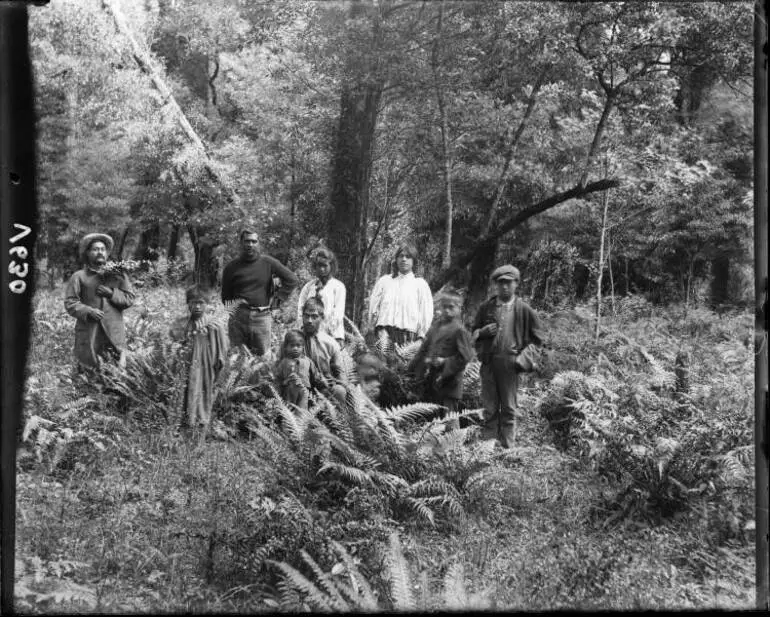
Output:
top-left (480, 354), bottom-right (519, 448)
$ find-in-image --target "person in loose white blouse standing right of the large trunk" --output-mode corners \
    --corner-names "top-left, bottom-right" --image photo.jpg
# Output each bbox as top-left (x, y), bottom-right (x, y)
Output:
top-left (369, 244), bottom-right (433, 345)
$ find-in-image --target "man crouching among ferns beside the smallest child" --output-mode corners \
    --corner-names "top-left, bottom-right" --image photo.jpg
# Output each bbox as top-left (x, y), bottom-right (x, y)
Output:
top-left (302, 296), bottom-right (348, 405)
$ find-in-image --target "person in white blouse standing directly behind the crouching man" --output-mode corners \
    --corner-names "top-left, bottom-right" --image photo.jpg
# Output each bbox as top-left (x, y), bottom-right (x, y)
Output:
top-left (297, 247), bottom-right (346, 345)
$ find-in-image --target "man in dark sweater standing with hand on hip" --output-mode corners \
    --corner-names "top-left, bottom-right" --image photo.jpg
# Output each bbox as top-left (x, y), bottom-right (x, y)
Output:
top-left (222, 229), bottom-right (299, 356)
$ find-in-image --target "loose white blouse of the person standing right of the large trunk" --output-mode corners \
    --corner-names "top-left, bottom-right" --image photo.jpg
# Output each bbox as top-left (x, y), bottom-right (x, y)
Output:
top-left (369, 272), bottom-right (433, 338)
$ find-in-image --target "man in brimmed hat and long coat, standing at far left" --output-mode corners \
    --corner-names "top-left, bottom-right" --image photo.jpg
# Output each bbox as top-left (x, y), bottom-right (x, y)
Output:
top-left (64, 233), bottom-right (134, 367)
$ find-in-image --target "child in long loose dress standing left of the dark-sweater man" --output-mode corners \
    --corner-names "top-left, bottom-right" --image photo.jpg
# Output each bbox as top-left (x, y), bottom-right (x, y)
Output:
top-left (170, 286), bottom-right (228, 429)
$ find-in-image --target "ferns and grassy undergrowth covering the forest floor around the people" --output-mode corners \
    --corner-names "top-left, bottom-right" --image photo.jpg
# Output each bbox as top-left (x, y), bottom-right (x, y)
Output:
top-left (16, 287), bottom-right (753, 612)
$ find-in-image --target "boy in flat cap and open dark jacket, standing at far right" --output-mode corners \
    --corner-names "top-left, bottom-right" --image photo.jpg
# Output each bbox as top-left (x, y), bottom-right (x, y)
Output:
top-left (473, 264), bottom-right (543, 448)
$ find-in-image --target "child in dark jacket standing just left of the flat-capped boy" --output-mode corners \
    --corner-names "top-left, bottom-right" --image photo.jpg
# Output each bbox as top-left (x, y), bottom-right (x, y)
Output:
top-left (409, 290), bottom-right (473, 428)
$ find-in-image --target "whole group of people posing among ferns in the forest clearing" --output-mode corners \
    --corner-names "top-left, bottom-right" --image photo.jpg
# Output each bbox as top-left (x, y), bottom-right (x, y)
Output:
top-left (64, 229), bottom-right (543, 448)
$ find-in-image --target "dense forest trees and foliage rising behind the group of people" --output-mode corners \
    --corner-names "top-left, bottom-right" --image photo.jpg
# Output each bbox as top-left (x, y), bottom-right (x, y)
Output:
top-left (31, 0), bottom-right (753, 318)
